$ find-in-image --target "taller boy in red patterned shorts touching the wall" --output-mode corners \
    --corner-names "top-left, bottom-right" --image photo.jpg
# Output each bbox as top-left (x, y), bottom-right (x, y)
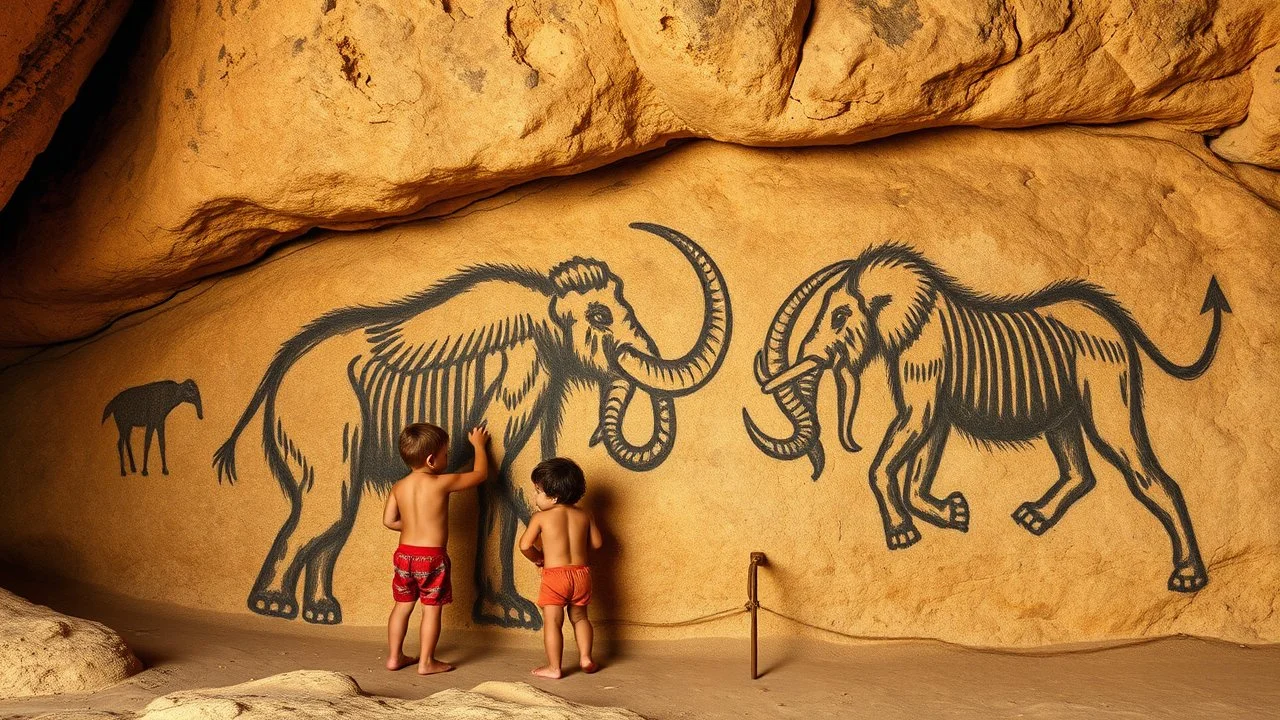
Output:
top-left (383, 423), bottom-right (489, 675)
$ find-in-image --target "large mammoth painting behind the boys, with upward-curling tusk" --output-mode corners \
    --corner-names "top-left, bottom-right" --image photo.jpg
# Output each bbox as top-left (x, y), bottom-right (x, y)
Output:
top-left (214, 223), bottom-right (731, 628)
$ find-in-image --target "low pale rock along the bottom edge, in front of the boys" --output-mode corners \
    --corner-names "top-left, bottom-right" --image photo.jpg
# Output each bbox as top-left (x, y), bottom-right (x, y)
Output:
top-left (127, 670), bottom-right (640, 720)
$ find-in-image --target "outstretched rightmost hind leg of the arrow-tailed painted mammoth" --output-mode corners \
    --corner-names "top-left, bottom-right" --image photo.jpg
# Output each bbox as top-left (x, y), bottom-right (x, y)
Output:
top-left (1082, 363), bottom-right (1208, 592)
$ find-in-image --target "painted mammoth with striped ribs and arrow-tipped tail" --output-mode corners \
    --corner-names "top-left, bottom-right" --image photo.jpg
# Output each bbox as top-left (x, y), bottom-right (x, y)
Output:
top-left (742, 245), bottom-right (1231, 592)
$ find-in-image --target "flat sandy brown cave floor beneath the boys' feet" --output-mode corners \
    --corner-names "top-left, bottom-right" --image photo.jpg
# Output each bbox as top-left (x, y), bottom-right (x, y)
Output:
top-left (0, 575), bottom-right (1280, 720)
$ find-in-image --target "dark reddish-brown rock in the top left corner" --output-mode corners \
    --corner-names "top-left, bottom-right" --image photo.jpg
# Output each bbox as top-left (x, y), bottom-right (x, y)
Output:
top-left (0, 0), bottom-right (129, 208)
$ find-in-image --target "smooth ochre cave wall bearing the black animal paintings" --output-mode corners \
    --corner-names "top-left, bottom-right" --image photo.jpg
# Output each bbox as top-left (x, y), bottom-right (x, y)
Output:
top-left (0, 124), bottom-right (1280, 646)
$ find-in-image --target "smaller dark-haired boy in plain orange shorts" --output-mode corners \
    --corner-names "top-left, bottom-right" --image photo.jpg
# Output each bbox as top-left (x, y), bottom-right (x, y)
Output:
top-left (520, 457), bottom-right (604, 680)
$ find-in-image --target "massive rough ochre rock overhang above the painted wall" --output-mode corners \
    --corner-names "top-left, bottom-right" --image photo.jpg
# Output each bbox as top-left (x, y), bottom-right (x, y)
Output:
top-left (0, 0), bottom-right (1280, 347)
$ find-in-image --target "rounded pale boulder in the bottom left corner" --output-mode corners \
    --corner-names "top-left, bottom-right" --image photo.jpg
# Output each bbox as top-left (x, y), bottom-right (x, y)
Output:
top-left (0, 589), bottom-right (142, 698)
